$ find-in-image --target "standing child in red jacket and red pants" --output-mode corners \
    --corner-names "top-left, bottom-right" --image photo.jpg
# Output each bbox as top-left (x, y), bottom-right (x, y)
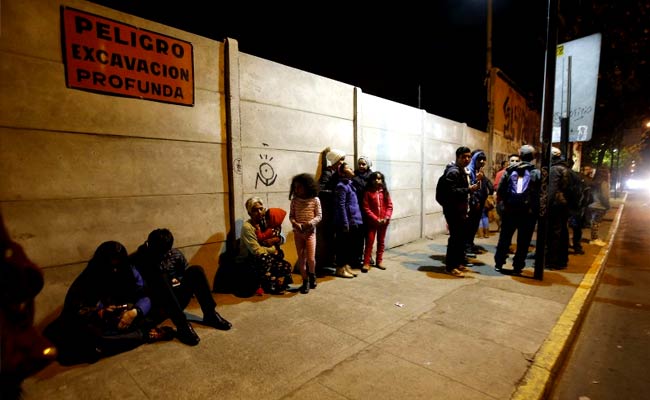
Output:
top-left (361, 171), bottom-right (393, 272)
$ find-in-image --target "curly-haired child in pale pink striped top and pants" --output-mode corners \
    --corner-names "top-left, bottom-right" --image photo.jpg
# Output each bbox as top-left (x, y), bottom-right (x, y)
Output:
top-left (289, 174), bottom-right (323, 294)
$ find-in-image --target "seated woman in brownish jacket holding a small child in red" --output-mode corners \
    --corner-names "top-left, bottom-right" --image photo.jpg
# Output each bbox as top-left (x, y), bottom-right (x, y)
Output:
top-left (237, 197), bottom-right (292, 295)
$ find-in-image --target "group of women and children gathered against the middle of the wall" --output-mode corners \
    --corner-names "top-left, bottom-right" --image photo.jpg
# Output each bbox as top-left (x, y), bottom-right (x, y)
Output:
top-left (232, 148), bottom-right (393, 294)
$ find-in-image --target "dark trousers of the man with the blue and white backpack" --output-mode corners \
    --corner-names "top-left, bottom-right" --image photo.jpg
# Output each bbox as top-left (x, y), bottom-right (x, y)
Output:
top-left (494, 210), bottom-right (537, 269)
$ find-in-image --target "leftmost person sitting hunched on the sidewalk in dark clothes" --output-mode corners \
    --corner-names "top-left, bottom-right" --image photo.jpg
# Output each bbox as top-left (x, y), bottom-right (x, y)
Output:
top-left (45, 241), bottom-right (174, 365)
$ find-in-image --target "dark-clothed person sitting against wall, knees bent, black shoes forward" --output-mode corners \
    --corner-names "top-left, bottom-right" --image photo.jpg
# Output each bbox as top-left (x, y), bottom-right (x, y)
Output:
top-left (132, 228), bottom-right (232, 346)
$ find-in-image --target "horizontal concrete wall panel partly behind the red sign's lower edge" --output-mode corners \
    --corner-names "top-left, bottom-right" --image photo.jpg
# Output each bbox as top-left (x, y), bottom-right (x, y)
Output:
top-left (0, 52), bottom-right (225, 143)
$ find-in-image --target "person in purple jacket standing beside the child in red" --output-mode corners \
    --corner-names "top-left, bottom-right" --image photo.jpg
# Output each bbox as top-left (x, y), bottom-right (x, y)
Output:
top-left (334, 163), bottom-right (363, 278)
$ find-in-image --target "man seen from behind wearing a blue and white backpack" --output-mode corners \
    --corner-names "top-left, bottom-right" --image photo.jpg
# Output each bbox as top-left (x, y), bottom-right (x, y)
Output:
top-left (494, 145), bottom-right (541, 275)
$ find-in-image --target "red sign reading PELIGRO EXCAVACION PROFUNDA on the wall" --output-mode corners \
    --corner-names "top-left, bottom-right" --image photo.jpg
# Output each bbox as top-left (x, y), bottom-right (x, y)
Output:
top-left (61, 7), bottom-right (194, 106)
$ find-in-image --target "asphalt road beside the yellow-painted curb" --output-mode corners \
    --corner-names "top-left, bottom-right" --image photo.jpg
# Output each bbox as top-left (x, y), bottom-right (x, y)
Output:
top-left (549, 188), bottom-right (650, 400)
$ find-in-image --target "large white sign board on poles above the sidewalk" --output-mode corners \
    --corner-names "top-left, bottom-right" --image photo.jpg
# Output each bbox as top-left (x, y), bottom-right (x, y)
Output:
top-left (553, 33), bottom-right (601, 143)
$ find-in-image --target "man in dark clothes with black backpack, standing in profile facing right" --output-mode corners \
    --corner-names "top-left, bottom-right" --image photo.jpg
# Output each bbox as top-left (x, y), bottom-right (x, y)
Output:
top-left (436, 146), bottom-right (479, 278)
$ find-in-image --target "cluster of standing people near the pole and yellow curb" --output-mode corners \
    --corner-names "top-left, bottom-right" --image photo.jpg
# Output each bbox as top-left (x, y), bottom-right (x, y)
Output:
top-left (441, 145), bottom-right (610, 277)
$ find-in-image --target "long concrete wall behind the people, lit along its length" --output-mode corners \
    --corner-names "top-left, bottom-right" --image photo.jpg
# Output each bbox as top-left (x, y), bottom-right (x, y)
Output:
top-left (0, 0), bottom-right (509, 321)
